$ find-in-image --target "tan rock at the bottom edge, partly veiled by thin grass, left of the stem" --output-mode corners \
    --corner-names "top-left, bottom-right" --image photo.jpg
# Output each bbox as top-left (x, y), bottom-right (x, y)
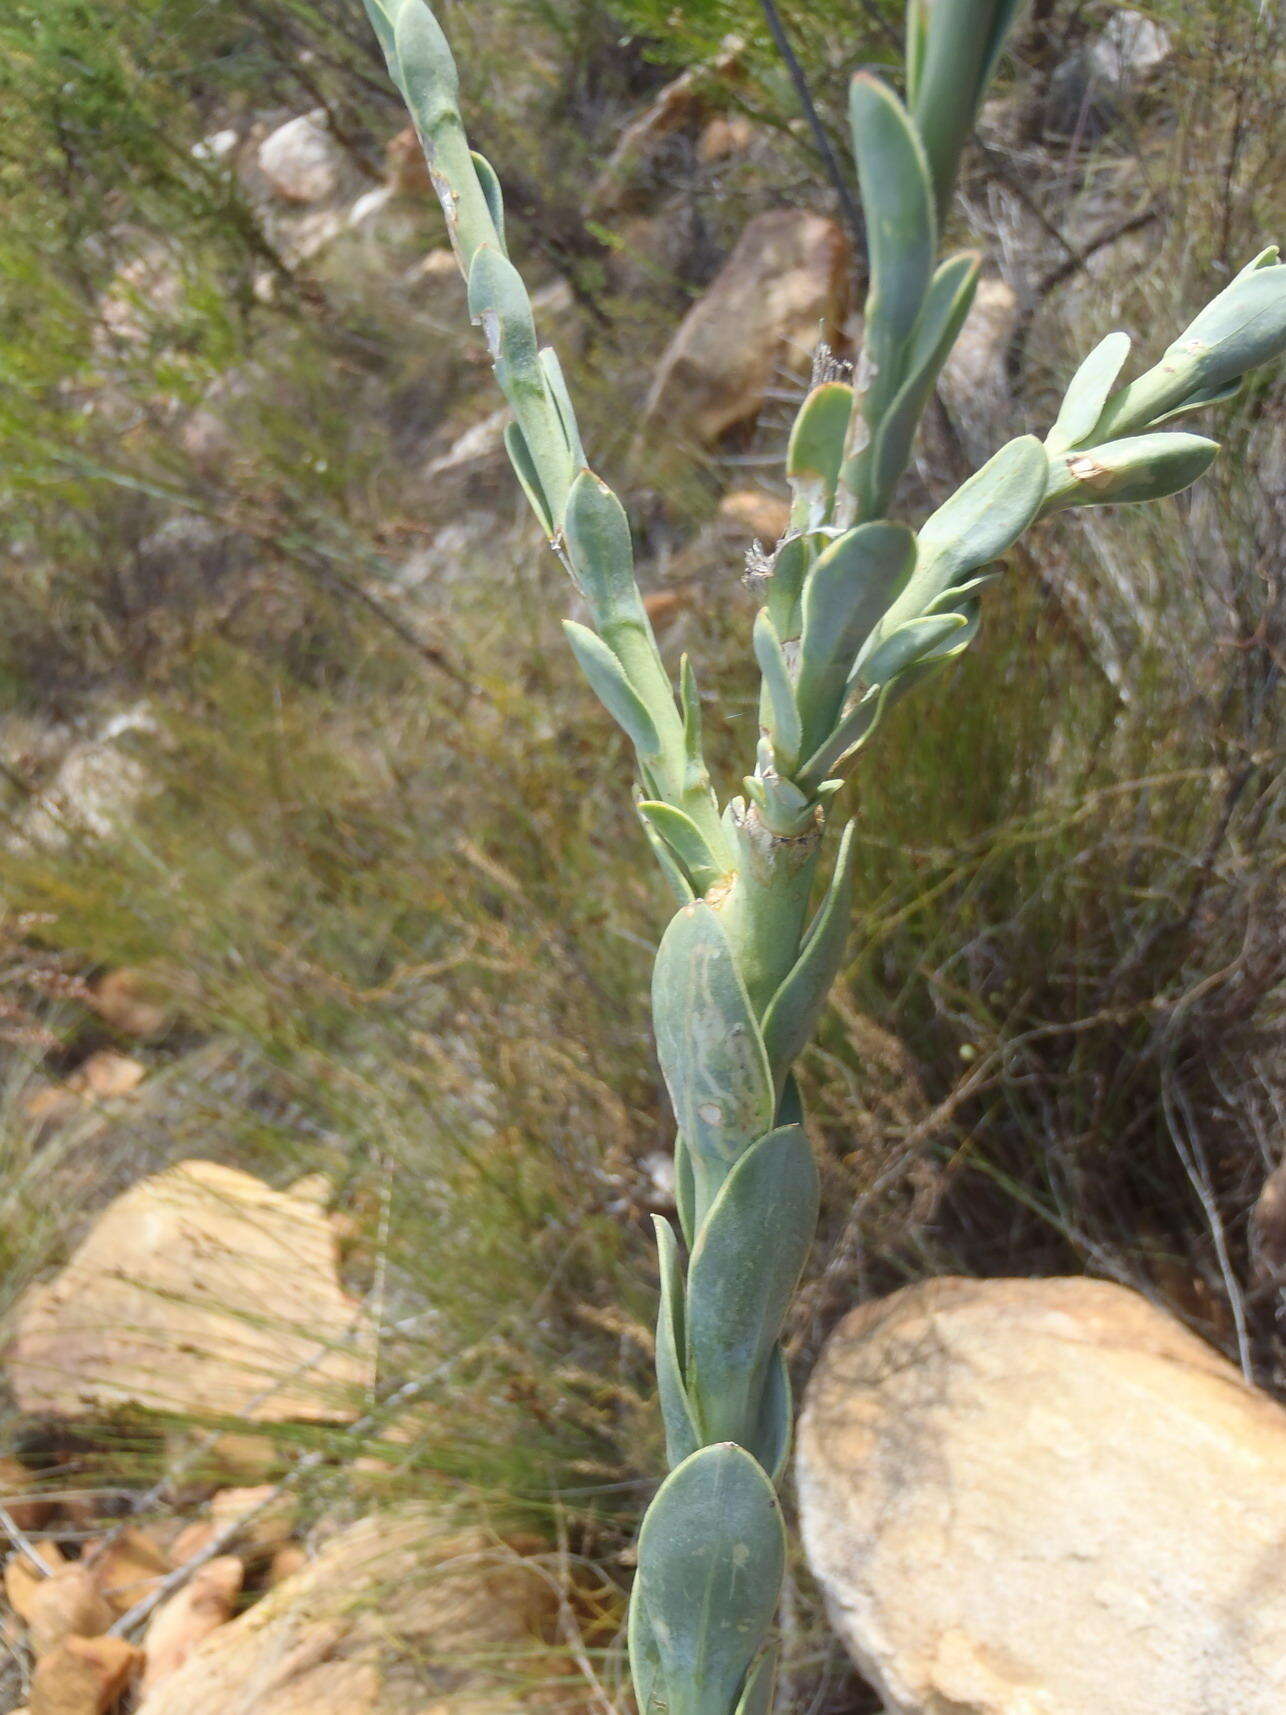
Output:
top-left (139, 1509), bottom-right (566, 1715)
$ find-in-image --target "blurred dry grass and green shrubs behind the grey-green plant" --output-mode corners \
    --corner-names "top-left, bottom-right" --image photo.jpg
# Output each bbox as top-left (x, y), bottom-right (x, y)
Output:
top-left (0, 0), bottom-right (1286, 1710)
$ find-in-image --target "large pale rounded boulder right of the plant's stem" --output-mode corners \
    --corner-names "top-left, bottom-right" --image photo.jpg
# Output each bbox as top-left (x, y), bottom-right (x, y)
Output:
top-left (796, 1279), bottom-right (1286, 1715)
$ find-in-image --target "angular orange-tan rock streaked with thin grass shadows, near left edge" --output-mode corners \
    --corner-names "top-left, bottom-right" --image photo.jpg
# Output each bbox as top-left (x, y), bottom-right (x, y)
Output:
top-left (5, 1161), bottom-right (374, 1422)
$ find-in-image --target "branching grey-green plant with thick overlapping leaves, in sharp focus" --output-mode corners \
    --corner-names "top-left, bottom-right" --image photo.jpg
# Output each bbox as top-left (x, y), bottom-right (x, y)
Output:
top-left (365, 0), bottom-right (1286, 1715)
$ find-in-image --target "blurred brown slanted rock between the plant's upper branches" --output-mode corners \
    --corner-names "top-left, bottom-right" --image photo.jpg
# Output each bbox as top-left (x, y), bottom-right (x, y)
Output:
top-left (645, 209), bottom-right (849, 446)
